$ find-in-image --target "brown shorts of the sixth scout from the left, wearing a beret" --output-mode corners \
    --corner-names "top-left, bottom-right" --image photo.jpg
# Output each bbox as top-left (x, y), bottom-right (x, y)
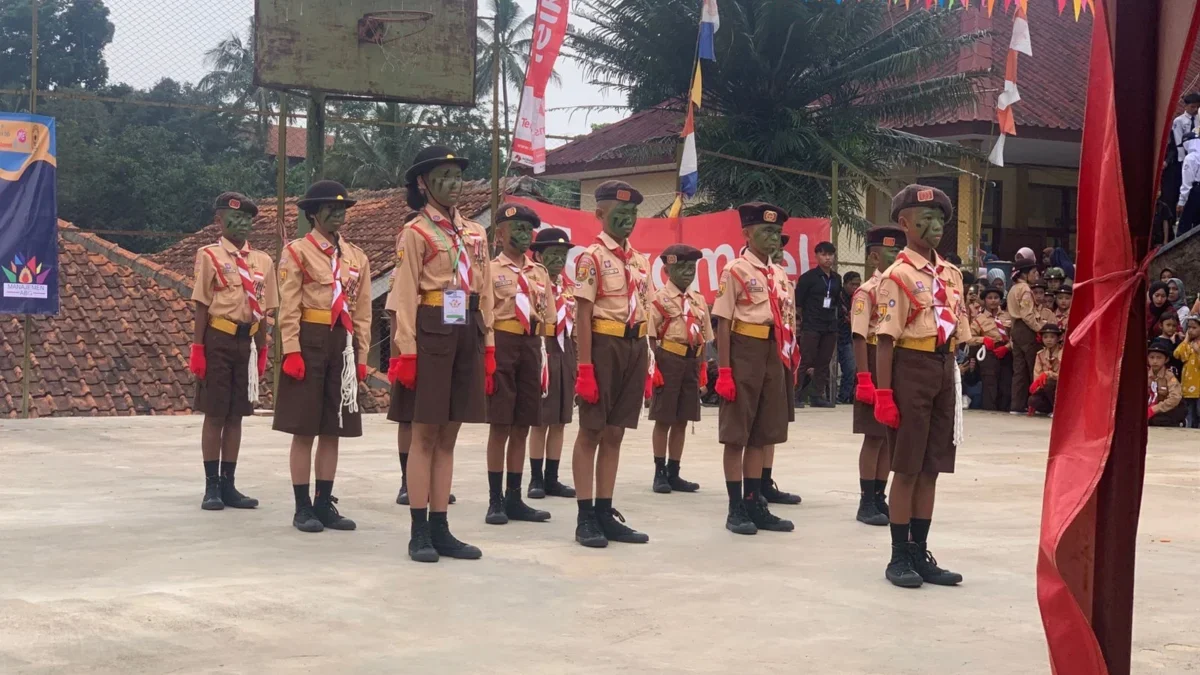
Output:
top-left (580, 333), bottom-right (649, 431)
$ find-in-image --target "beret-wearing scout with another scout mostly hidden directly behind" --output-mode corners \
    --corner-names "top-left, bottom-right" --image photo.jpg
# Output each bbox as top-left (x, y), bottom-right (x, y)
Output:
top-left (713, 202), bottom-right (794, 534)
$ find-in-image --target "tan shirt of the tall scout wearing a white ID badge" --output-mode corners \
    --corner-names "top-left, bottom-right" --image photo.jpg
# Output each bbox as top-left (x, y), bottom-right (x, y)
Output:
top-left (386, 207), bottom-right (496, 354)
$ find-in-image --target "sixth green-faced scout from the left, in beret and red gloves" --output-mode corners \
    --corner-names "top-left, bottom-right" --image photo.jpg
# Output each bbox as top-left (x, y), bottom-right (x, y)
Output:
top-left (572, 180), bottom-right (650, 548)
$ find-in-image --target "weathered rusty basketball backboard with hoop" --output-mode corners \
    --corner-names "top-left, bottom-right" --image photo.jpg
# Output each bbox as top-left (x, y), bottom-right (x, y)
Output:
top-left (254, 0), bottom-right (476, 106)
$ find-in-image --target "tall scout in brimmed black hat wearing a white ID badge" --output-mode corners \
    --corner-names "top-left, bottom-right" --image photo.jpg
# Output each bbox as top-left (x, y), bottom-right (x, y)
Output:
top-left (388, 145), bottom-right (496, 562)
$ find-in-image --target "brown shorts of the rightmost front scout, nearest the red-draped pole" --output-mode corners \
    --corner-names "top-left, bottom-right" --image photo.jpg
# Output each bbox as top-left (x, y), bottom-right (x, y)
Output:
top-left (888, 347), bottom-right (962, 474)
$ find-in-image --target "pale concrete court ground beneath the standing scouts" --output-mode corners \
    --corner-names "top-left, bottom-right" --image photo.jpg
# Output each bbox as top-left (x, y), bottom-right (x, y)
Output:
top-left (0, 406), bottom-right (1200, 675)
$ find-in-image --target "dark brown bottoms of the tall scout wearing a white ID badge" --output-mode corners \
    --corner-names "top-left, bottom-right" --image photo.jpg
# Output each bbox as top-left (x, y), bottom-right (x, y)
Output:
top-left (388, 305), bottom-right (489, 424)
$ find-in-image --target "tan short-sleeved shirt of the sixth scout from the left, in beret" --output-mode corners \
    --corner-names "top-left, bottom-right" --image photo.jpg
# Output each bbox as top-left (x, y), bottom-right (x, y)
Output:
top-left (575, 232), bottom-right (650, 323)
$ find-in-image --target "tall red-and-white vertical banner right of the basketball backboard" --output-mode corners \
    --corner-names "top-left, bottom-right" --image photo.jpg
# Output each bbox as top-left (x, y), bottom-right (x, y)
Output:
top-left (512, 0), bottom-right (571, 173)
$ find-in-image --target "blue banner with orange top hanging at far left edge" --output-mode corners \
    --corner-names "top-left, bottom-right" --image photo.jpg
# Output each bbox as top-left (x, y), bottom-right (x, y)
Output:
top-left (0, 113), bottom-right (59, 315)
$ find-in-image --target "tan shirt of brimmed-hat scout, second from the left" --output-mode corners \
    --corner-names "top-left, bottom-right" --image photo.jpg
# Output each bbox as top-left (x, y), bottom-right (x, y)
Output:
top-left (278, 229), bottom-right (371, 364)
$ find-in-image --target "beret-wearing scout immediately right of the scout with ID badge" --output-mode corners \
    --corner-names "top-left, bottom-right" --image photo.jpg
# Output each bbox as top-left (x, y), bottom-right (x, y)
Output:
top-left (484, 204), bottom-right (554, 525)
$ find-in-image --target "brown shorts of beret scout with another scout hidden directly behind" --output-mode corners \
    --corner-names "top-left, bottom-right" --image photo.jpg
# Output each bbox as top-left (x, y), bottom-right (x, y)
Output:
top-left (714, 333), bottom-right (792, 448)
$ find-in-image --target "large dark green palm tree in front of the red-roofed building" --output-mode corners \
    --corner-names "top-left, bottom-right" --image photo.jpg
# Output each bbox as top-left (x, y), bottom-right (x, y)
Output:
top-left (568, 0), bottom-right (985, 229)
